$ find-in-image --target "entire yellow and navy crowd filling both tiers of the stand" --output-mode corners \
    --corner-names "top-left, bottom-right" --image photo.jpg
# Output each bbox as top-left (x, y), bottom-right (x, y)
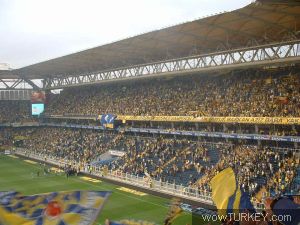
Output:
top-left (0, 70), bottom-right (300, 207)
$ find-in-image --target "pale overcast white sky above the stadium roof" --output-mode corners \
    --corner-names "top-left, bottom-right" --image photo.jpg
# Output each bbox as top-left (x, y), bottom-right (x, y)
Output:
top-left (0, 0), bottom-right (252, 69)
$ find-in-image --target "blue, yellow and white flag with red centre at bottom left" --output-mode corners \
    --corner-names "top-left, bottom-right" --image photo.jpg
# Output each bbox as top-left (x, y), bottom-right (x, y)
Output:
top-left (0, 191), bottom-right (110, 225)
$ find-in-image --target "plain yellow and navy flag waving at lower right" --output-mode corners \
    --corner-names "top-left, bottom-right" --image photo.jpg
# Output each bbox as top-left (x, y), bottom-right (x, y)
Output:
top-left (210, 167), bottom-right (254, 216)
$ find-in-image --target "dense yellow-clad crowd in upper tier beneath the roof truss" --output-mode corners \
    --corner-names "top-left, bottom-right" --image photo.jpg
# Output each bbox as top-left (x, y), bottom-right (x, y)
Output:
top-left (47, 71), bottom-right (300, 117)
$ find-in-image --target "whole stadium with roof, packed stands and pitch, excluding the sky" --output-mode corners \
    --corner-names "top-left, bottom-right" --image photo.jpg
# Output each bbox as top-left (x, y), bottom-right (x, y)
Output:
top-left (0, 0), bottom-right (300, 225)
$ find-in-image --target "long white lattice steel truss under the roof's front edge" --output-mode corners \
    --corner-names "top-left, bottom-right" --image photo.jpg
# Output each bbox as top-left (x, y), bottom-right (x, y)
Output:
top-left (44, 40), bottom-right (300, 90)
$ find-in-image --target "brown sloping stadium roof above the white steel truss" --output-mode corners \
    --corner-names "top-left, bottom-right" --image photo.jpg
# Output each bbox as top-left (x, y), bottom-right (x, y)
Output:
top-left (0, 0), bottom-right (300, 79)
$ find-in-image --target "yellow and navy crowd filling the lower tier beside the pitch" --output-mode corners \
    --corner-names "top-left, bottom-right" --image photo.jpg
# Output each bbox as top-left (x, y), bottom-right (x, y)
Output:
top-left (0, 128), bottom-right (300, 200)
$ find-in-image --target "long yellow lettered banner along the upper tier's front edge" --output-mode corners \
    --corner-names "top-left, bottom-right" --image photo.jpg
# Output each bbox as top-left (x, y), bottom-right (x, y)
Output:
top-left (118, 115), bottom-right (300, 125)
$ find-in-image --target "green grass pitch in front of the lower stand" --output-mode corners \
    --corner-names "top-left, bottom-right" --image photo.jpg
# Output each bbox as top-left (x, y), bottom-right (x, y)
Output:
top-left (0, 155), bottom-right (198, 225)
